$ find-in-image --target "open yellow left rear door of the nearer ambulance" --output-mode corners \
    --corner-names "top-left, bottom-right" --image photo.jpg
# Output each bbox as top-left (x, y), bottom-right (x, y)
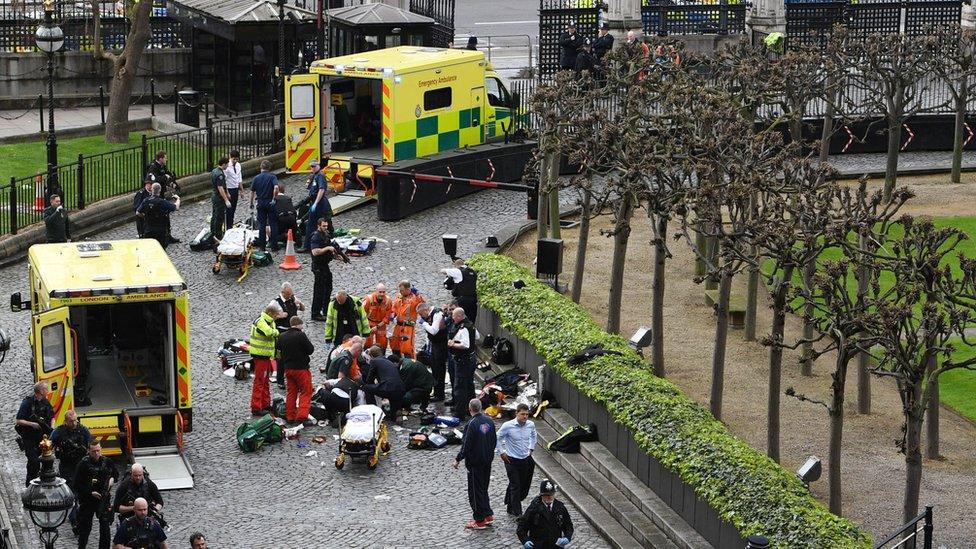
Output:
top-left (31, 307), bottom-right (78, 427)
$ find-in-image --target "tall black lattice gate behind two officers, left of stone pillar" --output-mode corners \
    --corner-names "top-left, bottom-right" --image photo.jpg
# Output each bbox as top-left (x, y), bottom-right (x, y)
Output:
top-left (539, 0), bottom-right (600, 79)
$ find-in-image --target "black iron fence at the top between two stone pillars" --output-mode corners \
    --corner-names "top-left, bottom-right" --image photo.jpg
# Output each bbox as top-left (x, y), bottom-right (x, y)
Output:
top-left (641, 0), bottom-right (746, 35)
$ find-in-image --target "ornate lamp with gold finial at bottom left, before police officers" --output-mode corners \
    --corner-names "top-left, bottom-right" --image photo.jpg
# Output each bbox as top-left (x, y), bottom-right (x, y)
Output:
top-left (21, 436), bottom-right (75, 549)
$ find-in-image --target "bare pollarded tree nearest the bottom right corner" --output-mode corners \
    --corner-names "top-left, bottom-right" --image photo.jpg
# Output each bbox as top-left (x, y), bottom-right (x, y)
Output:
top-left (867, 215), bottom-right (976, 522)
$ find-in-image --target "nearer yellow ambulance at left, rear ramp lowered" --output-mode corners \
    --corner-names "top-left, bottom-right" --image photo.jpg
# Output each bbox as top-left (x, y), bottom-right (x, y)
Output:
top-left (10, 239), bottom-right (193, 489)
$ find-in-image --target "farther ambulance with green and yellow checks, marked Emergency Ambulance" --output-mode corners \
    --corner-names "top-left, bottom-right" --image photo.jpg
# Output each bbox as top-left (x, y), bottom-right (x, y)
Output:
top-left (285, 46), bottom-right (514, 178)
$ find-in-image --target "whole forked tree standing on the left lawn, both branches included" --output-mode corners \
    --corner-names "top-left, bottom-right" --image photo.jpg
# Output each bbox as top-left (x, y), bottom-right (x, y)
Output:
top-left (88, 0), bottom-right (152, 143)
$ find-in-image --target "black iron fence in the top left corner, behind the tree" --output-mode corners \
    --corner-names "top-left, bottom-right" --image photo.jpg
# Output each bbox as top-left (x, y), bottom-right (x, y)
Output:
top-left (0, 0), bottom-right (189, 53)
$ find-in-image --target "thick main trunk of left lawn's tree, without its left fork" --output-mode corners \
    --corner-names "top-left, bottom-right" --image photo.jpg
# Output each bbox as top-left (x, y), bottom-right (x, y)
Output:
top-left (105, 0), bottom-right (153, 143)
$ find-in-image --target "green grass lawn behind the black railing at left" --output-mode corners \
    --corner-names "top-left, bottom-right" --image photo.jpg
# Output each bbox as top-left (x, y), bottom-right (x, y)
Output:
top-left (0, 131), bottom-right (155, 182)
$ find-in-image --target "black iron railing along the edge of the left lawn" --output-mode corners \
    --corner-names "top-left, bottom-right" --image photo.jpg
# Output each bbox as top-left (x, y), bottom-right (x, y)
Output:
top-left (0, 108), bottom-right (284, 235)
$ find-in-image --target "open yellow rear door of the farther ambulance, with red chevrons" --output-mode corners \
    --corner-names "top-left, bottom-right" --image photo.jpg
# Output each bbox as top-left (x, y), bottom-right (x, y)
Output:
top-left (285, 74), bottom-right (332, 173)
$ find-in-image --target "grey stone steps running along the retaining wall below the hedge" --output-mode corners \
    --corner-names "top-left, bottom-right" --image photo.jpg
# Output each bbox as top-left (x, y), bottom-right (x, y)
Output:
top-left (536, 408), bottom-right (712, 549)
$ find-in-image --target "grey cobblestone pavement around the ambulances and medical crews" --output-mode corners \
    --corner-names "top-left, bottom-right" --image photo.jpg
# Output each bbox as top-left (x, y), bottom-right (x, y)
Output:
top-left (0, 178), bottom-right (607, 548)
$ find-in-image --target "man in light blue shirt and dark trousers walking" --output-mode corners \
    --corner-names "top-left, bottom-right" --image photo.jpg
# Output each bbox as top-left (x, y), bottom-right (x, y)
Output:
top-left (495, 404), bottom-right (536, 517)
